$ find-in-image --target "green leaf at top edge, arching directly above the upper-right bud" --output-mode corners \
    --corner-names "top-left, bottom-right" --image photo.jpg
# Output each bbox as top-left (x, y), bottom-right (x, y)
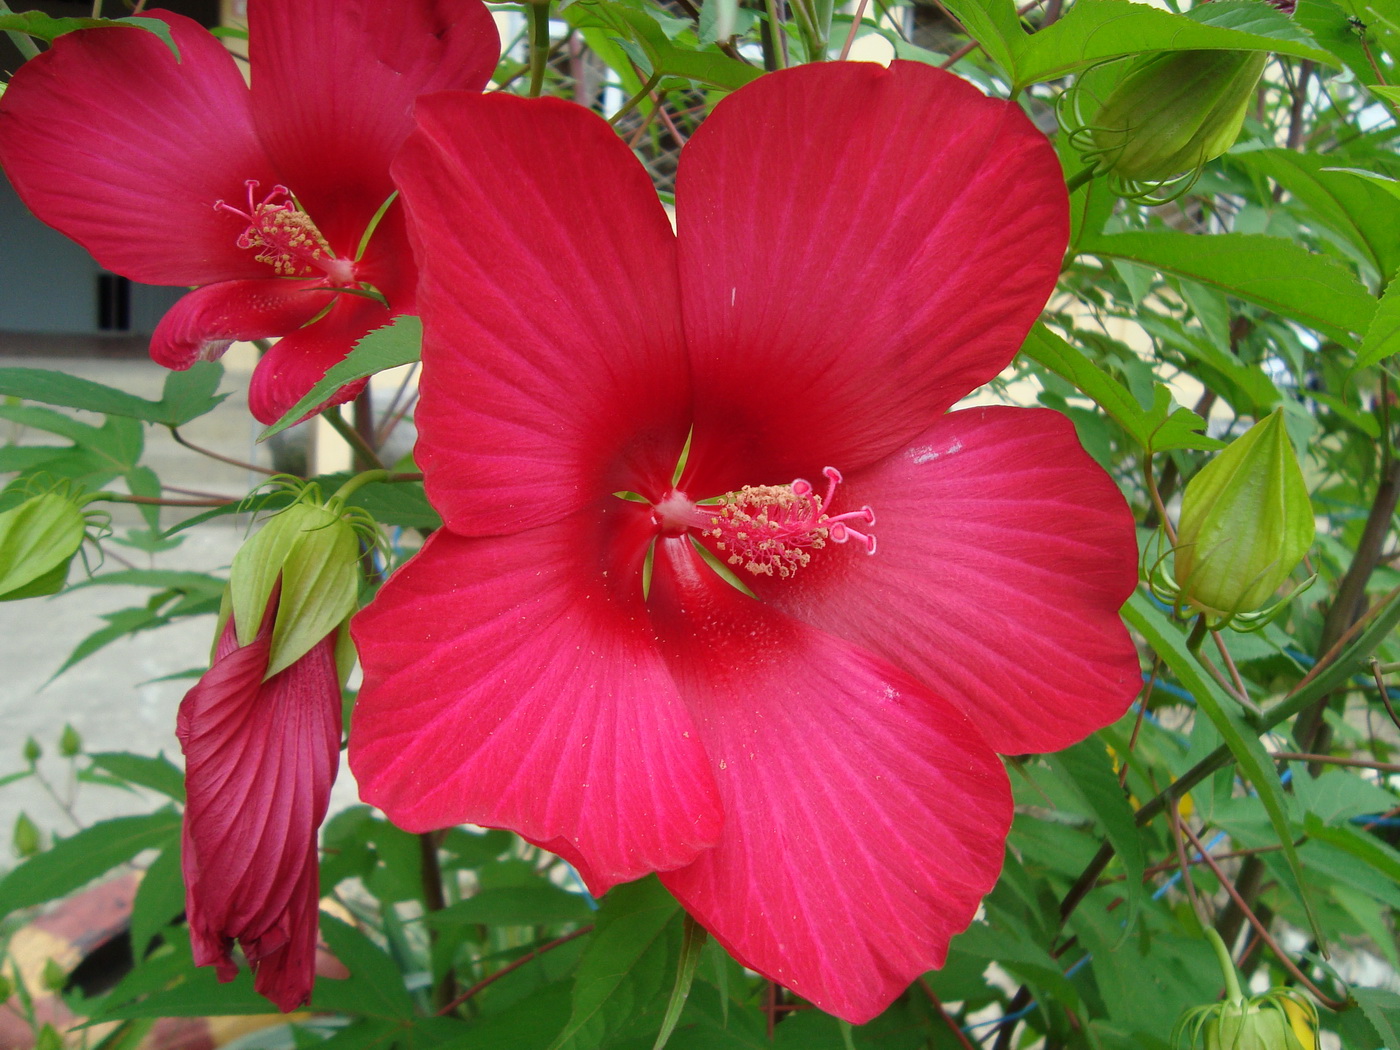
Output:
top-left (1013, 0), bottom-right (1337, 90)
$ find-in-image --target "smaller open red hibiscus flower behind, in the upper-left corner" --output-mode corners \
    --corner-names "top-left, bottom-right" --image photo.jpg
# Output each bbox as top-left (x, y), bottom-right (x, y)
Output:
top-left (0, 0), bottom-right (500, 423)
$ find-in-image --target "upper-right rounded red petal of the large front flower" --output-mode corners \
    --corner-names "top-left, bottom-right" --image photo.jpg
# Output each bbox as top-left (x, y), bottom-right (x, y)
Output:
top-left (676, 62), bottom-right (1068, 494)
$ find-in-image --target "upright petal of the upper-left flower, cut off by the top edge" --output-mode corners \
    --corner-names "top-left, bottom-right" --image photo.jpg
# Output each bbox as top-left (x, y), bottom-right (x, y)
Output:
top-left (248, 0), bottom-right (501, 252)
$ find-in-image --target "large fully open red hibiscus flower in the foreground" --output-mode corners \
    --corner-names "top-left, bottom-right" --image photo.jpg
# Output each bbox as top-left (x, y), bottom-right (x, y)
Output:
top-left (350, 62), bottom-right (1140, 1022)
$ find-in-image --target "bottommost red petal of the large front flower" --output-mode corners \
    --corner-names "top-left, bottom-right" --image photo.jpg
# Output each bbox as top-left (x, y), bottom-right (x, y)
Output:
top-left (651, 539), bottom-right (1011, 1023)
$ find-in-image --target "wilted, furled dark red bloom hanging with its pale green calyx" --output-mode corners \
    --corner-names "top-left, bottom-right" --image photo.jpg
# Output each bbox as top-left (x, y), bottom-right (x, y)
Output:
top-left (178, 484), bottom-right (382, 1011)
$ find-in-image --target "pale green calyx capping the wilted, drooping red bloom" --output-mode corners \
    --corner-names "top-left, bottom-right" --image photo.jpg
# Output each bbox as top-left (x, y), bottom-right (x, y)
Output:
top-left (228, 472), bottom-right (384, 678)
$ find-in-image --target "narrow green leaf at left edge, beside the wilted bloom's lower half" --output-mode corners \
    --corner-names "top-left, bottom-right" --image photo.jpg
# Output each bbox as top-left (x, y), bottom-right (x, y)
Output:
top-left (0, 809), bottom-right (179, 917)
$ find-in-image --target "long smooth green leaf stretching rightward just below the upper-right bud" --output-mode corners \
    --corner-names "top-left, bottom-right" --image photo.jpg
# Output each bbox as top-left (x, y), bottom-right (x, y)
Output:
top-left (1082, 232), bottom-right (1376, 346)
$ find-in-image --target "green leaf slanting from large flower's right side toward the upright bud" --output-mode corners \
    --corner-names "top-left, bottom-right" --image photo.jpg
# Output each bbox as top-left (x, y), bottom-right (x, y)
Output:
top-left (1021, 322), bottom-right (1221, 452)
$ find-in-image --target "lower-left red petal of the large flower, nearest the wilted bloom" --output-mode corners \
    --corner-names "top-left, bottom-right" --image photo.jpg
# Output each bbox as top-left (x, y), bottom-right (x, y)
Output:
top-left (350, 515), bottom-right (721, 893)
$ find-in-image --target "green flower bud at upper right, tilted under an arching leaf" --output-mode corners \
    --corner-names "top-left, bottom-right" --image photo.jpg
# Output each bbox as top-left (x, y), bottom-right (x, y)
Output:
top-left (1085, 50), bottom-right (1268, 182)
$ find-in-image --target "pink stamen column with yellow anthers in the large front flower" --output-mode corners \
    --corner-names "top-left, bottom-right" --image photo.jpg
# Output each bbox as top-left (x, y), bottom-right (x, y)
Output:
top-left (651, 466), bottom-right (875, 577)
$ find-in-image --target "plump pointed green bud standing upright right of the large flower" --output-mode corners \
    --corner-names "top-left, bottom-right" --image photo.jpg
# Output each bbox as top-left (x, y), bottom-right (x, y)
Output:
top-left (1176, 409), bottom-right (1313, 620)
